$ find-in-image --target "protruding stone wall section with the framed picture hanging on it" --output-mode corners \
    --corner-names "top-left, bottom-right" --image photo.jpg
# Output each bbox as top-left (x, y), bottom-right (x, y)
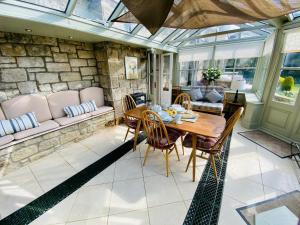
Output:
top-left (94, 42), bottom-right (147, 117)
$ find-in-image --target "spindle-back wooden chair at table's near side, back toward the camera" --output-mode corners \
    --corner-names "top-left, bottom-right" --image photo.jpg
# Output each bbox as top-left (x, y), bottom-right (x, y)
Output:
top-left (142, 110), bottom-right (180, 177)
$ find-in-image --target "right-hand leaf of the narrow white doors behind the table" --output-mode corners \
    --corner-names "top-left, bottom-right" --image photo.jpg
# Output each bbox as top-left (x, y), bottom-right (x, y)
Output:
top-left (159, 53), bottom-right (173, 106)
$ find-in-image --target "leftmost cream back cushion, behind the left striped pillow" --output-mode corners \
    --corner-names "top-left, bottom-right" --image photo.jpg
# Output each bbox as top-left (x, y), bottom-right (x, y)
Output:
top-left (1, 95), bottom-right (52, 123)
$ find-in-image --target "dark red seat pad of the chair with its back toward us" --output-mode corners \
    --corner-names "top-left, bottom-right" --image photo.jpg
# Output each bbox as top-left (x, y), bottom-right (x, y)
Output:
top-left (147, 129), bottom-right (180, 149)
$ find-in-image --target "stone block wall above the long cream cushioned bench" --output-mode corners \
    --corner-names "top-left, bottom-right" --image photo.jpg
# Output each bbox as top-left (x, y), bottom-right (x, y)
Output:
top-left (0, 32), bottom-right (99, 102)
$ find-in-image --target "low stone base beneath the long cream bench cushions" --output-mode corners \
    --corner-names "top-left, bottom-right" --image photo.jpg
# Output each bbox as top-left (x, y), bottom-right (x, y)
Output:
top-left (0, 112), bottom-right (114, 177)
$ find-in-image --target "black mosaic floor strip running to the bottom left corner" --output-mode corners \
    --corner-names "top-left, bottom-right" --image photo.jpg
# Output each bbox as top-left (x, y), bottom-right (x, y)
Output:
top-left (0, 134), bottom-right (146, 225)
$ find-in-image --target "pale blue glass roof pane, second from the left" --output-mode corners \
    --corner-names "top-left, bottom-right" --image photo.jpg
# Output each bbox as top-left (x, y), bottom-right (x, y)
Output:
top-left (73, 0), bottom-right (119, 22)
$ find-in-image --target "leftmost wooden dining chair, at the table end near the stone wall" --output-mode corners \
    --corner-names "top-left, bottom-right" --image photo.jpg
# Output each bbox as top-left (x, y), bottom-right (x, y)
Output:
top-left (122, 95), bottom-right (139, 142)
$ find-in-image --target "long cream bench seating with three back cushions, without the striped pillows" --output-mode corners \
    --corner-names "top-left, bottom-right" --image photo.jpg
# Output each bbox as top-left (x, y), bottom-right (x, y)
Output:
top-left (0, 87), bottom-right (113, 148)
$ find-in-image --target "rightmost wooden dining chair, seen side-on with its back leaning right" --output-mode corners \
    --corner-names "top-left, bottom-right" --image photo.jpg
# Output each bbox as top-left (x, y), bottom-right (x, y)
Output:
top-left (183, 107), bottom-right (244, 179)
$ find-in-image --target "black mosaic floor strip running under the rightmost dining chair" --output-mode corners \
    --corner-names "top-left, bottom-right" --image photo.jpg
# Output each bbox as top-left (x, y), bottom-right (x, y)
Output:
top-left (183, 136), bottom-right (231, 225)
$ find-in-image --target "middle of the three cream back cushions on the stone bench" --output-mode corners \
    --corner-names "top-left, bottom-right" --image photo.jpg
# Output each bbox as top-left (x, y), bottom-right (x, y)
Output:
top-left (47, 91), bottom-right (80, 119)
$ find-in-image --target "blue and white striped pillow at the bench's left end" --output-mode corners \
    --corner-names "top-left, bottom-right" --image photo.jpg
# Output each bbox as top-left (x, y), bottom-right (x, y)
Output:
top-left (0, 112), bottom-right (40, 137)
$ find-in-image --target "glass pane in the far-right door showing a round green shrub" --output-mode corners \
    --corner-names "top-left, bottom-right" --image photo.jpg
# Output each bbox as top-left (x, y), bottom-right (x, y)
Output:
top-left (273, 53), bottom-right (300, 105)
